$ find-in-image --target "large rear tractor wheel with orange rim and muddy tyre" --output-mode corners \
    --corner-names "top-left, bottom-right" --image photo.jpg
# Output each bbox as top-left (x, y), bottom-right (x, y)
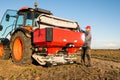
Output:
top-left (10, 31), bottom-right (32, 65)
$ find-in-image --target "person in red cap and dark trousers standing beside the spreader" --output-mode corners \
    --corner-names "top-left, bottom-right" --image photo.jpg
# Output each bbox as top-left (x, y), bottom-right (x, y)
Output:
top-left (81, 26), bottom-right (92, 67)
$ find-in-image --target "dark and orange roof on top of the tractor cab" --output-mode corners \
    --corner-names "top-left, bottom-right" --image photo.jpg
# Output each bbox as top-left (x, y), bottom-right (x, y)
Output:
top-left (18, 7), bottom-right (52, 15)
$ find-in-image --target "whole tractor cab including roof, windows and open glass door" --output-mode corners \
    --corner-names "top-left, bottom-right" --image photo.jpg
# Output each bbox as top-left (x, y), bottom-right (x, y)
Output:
top-left (0, 7), bottom-right (52, 38)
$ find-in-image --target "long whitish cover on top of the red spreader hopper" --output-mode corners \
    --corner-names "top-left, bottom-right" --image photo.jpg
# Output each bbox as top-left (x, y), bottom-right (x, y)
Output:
top-left (36, 14), bottom-right (78, 28)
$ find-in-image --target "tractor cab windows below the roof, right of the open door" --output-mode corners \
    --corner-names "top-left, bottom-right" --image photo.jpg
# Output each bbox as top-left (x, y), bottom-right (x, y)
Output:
top-left (16, 11), bottom-right (40, 27)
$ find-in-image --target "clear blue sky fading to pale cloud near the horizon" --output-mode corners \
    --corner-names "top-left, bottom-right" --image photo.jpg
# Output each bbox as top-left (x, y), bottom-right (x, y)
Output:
top-left (0, 0), bottom-right (120, 49)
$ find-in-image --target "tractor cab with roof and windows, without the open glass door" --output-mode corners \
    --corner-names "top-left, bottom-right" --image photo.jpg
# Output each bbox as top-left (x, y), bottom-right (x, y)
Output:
top-left (17, 7), bottom-right (52, 27)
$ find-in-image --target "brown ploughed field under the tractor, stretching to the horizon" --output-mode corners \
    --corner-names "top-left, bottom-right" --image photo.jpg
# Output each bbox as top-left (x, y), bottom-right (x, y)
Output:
top-left (0, 49), bottom-right (120, 80)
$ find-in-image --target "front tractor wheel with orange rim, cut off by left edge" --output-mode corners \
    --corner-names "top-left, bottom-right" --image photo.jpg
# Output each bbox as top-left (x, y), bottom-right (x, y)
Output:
top-left (0, 39), bottom-right (10, 60)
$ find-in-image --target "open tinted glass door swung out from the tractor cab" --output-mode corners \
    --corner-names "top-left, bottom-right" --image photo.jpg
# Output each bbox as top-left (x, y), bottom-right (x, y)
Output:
top-left (0, 10), bottom-right (17, 39)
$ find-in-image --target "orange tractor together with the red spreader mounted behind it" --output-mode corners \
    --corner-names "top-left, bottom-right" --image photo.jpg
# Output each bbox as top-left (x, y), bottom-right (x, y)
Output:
top-left (0, 5), bottom-right (85, 65)
